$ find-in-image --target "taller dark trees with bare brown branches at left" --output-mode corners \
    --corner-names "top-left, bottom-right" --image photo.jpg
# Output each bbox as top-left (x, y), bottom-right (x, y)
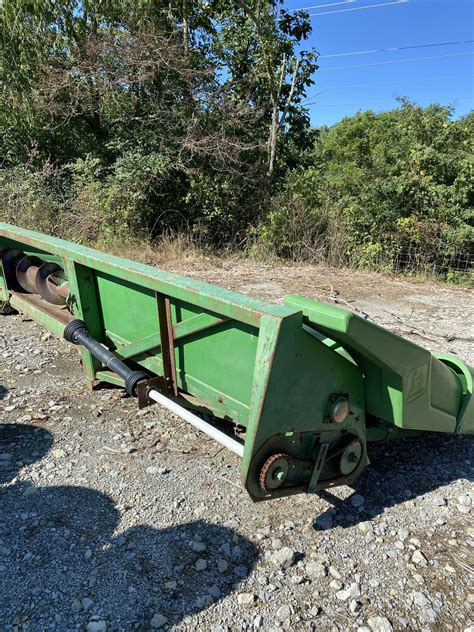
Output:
top-left (0, 0), bottom-right (316, 243)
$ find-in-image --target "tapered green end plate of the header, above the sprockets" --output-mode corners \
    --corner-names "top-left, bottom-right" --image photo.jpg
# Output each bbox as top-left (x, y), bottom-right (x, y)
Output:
top-left (241, 313), bottom-right (367, 500)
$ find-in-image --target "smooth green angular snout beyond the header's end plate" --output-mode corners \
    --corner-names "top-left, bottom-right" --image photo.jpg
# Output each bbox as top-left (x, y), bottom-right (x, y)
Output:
top-left (285, 296), bottom-right (474, 432)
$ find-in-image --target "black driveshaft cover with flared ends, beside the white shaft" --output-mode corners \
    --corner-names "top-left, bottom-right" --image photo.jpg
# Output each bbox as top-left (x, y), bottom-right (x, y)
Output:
top-left (63, 319), bottom-right (150, 395)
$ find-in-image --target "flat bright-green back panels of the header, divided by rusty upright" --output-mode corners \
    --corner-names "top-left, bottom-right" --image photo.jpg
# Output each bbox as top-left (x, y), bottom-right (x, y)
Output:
top-left (95, 272), bottom-right (258, 425)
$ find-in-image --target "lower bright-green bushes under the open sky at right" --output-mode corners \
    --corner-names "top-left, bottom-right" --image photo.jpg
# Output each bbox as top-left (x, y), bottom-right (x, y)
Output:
top-left (261, 100), bottom-right (474, 272)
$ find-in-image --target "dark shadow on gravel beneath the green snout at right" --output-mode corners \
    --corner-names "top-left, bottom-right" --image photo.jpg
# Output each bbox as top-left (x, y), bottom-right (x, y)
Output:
top-left (314, 433), bottom-right (474, 530)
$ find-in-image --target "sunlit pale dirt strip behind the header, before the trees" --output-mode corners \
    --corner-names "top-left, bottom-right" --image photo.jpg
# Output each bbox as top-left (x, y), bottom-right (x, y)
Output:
top-left (163, 258), bottom-right (474, 365)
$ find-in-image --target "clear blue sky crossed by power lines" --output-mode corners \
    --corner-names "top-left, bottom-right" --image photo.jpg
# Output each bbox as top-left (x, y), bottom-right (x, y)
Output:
top-left (285, 0), bottom-right (474, 126)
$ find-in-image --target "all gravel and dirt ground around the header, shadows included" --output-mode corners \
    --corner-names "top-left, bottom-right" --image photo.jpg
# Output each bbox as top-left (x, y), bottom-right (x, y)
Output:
top-left (0, 261), bottom-right (474, 632)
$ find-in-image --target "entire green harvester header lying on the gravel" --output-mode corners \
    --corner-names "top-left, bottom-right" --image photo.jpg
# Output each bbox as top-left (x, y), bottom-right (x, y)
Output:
top-left (0, 223), bottom-right (474, 500)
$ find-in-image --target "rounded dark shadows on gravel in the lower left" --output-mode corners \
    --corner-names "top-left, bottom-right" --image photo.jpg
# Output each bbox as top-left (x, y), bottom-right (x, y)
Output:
top-left (0, 424), bottom-right (258, 632)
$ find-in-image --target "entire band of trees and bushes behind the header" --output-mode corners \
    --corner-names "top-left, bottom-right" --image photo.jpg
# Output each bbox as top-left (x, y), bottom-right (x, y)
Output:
top-left (0, 0), bottom-right (474, 274)
